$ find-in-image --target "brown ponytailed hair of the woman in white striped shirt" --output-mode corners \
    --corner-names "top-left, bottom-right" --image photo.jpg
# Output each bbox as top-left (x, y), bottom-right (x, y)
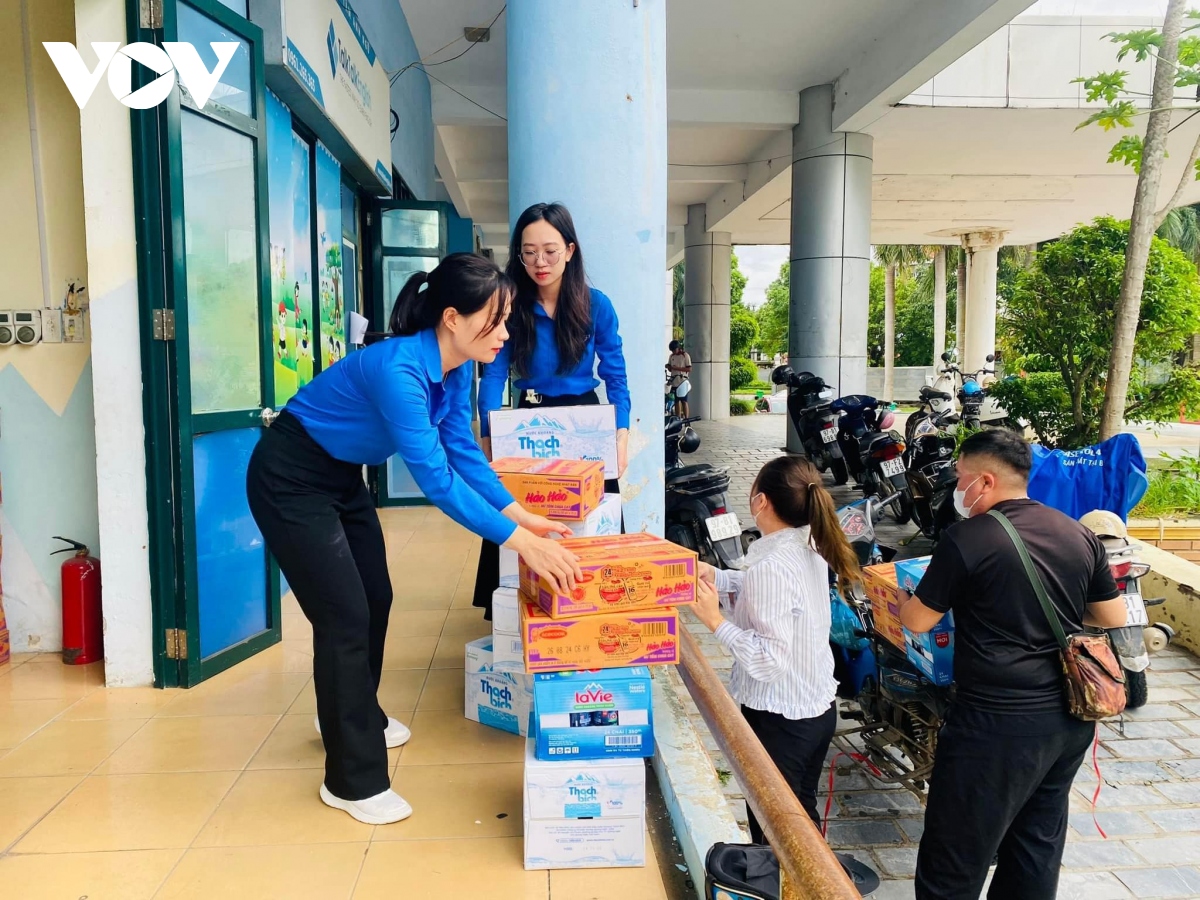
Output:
top-left (754, 456), bottom-right (863, 584)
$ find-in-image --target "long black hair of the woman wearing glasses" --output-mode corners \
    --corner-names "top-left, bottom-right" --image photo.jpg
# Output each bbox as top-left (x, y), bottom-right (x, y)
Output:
top-left (508, 203), bottom-right (592, 377)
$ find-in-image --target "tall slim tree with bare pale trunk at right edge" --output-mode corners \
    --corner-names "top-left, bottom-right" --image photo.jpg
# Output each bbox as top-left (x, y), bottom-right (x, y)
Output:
top-left (1076, 0), bottom-right (1200, 438)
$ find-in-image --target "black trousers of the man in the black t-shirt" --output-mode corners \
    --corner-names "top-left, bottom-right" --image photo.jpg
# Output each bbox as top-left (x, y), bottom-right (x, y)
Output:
top-left (917, 706), bottom-right (1096, 900)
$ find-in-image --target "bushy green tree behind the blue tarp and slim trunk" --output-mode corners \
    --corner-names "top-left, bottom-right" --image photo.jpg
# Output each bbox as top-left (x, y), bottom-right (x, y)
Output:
top-left (992, 217), bottom-right (1200, 448)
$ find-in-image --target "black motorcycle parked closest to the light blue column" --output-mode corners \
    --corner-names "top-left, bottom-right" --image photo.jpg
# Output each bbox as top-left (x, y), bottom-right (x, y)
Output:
top-left (665, 415), bottom-right (746, 569)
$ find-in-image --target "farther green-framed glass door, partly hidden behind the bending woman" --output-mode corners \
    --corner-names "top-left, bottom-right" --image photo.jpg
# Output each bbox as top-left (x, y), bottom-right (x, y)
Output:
top-left (370, 200), bottom-right (446, 506)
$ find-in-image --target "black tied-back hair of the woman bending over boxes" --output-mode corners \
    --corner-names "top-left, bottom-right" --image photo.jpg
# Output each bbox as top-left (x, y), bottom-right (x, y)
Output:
top-left (388, 253), bottom-right (514, 335)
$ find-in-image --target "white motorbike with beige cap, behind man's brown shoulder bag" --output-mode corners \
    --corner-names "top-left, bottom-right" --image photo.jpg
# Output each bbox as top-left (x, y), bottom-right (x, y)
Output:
top-left (1080, 510), bottom-right (1175, 709)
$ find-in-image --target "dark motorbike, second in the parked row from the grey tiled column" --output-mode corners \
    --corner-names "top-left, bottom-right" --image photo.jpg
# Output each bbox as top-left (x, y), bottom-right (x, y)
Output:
top-left (830, 394), bottom-right (912, 524)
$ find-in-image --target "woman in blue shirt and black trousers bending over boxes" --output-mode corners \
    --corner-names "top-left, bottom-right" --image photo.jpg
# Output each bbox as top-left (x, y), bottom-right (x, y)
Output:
top-left (246, 253), bottom-right (580, 824)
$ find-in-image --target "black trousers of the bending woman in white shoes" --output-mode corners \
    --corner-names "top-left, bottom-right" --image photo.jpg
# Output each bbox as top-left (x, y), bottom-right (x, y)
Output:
top-left (246, 410), bottom-right (391, 800)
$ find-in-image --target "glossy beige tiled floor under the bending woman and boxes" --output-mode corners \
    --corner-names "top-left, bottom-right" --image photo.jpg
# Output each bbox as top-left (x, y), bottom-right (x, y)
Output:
top-left (0, 510), bottom-right (666, 900)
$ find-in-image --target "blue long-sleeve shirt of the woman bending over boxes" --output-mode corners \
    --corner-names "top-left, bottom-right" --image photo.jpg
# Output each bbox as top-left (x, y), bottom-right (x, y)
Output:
top-left (286, 329), bottom-right (516, 544)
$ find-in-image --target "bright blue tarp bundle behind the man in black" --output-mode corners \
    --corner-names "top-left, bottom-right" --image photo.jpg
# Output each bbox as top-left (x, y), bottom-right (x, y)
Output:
top-left (1030, 434), bottom-right (1148, 520)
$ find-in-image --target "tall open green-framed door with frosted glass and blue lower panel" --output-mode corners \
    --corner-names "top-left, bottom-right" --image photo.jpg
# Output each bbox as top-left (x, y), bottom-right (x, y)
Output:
top-left (138, 0), bottom-right (277, 686)
